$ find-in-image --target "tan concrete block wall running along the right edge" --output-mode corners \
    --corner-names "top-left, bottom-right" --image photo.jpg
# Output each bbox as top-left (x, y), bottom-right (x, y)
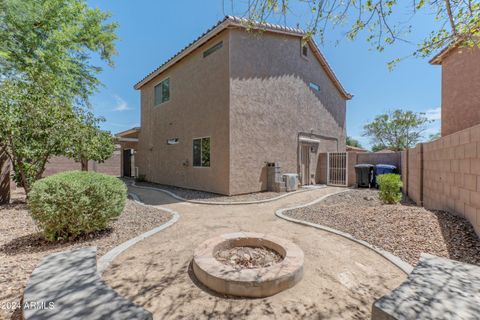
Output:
top-left (402, 125), bottom-right (480, 236)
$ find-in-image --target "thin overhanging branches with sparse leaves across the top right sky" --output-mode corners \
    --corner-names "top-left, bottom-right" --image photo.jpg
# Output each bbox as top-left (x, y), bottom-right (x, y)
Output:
top-left (230, 0), bottom-right (480, 66)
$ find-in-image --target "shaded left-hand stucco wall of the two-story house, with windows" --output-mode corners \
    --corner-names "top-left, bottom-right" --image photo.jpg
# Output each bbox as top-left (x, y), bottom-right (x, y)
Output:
top-left (135, 30), bottom-right (230, 194)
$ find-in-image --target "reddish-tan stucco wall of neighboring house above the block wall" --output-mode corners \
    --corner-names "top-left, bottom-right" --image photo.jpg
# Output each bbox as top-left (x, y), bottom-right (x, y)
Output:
top-left (442, 48), bottom-right (480, 136)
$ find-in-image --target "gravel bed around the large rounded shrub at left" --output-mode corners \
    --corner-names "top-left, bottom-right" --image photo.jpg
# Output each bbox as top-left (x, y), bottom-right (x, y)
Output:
top-left (0, 191), bottom-right (171, 319)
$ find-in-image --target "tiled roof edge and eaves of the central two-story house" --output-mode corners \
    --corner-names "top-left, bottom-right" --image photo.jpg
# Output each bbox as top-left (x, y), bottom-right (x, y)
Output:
top-left (134, 16), bottom-right (353, 100)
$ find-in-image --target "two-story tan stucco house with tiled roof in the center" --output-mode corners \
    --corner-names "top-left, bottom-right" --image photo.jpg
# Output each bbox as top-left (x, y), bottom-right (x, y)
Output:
top-left (135, 17), bottom-right (351, 195)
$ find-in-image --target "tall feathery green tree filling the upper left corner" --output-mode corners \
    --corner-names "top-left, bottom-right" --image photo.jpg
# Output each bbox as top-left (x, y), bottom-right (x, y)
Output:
top-left (0, 0), bottom-right (117, 193)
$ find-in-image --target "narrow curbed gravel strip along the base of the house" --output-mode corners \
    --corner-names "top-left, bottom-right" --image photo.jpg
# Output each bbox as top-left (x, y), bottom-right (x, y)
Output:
top-left (136, 182), bottom-right (286, 202)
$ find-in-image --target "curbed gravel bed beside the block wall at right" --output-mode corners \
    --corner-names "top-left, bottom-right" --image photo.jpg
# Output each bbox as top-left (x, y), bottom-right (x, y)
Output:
top-left (285, 189), bottom-right (480, 265)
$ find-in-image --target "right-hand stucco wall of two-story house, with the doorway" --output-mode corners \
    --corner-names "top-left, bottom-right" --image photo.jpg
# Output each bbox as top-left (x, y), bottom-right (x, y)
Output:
top-left (228, 30), bottom-right (346, 194)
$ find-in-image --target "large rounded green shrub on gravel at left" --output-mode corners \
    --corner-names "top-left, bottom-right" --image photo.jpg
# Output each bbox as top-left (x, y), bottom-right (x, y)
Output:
top-left (28, 171), bottom-right (127, 241)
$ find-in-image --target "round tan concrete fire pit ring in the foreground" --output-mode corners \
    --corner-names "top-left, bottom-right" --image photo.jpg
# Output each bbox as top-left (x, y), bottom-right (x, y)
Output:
top-left (193, 232), bottom-right (303, 298)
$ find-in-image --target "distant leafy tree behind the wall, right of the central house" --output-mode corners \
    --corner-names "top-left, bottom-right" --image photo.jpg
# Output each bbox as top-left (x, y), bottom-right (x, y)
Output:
top-left (363, 109), bottom-right (430, 151)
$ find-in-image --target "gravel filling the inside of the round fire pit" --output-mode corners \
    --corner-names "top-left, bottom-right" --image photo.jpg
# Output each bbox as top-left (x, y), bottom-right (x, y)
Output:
top-left (215, 247), bottom-right (282, 270)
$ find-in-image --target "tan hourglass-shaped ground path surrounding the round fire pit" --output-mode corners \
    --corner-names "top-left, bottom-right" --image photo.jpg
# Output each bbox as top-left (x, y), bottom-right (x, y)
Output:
top-left (103, 187), bottom-right (406, 319)
